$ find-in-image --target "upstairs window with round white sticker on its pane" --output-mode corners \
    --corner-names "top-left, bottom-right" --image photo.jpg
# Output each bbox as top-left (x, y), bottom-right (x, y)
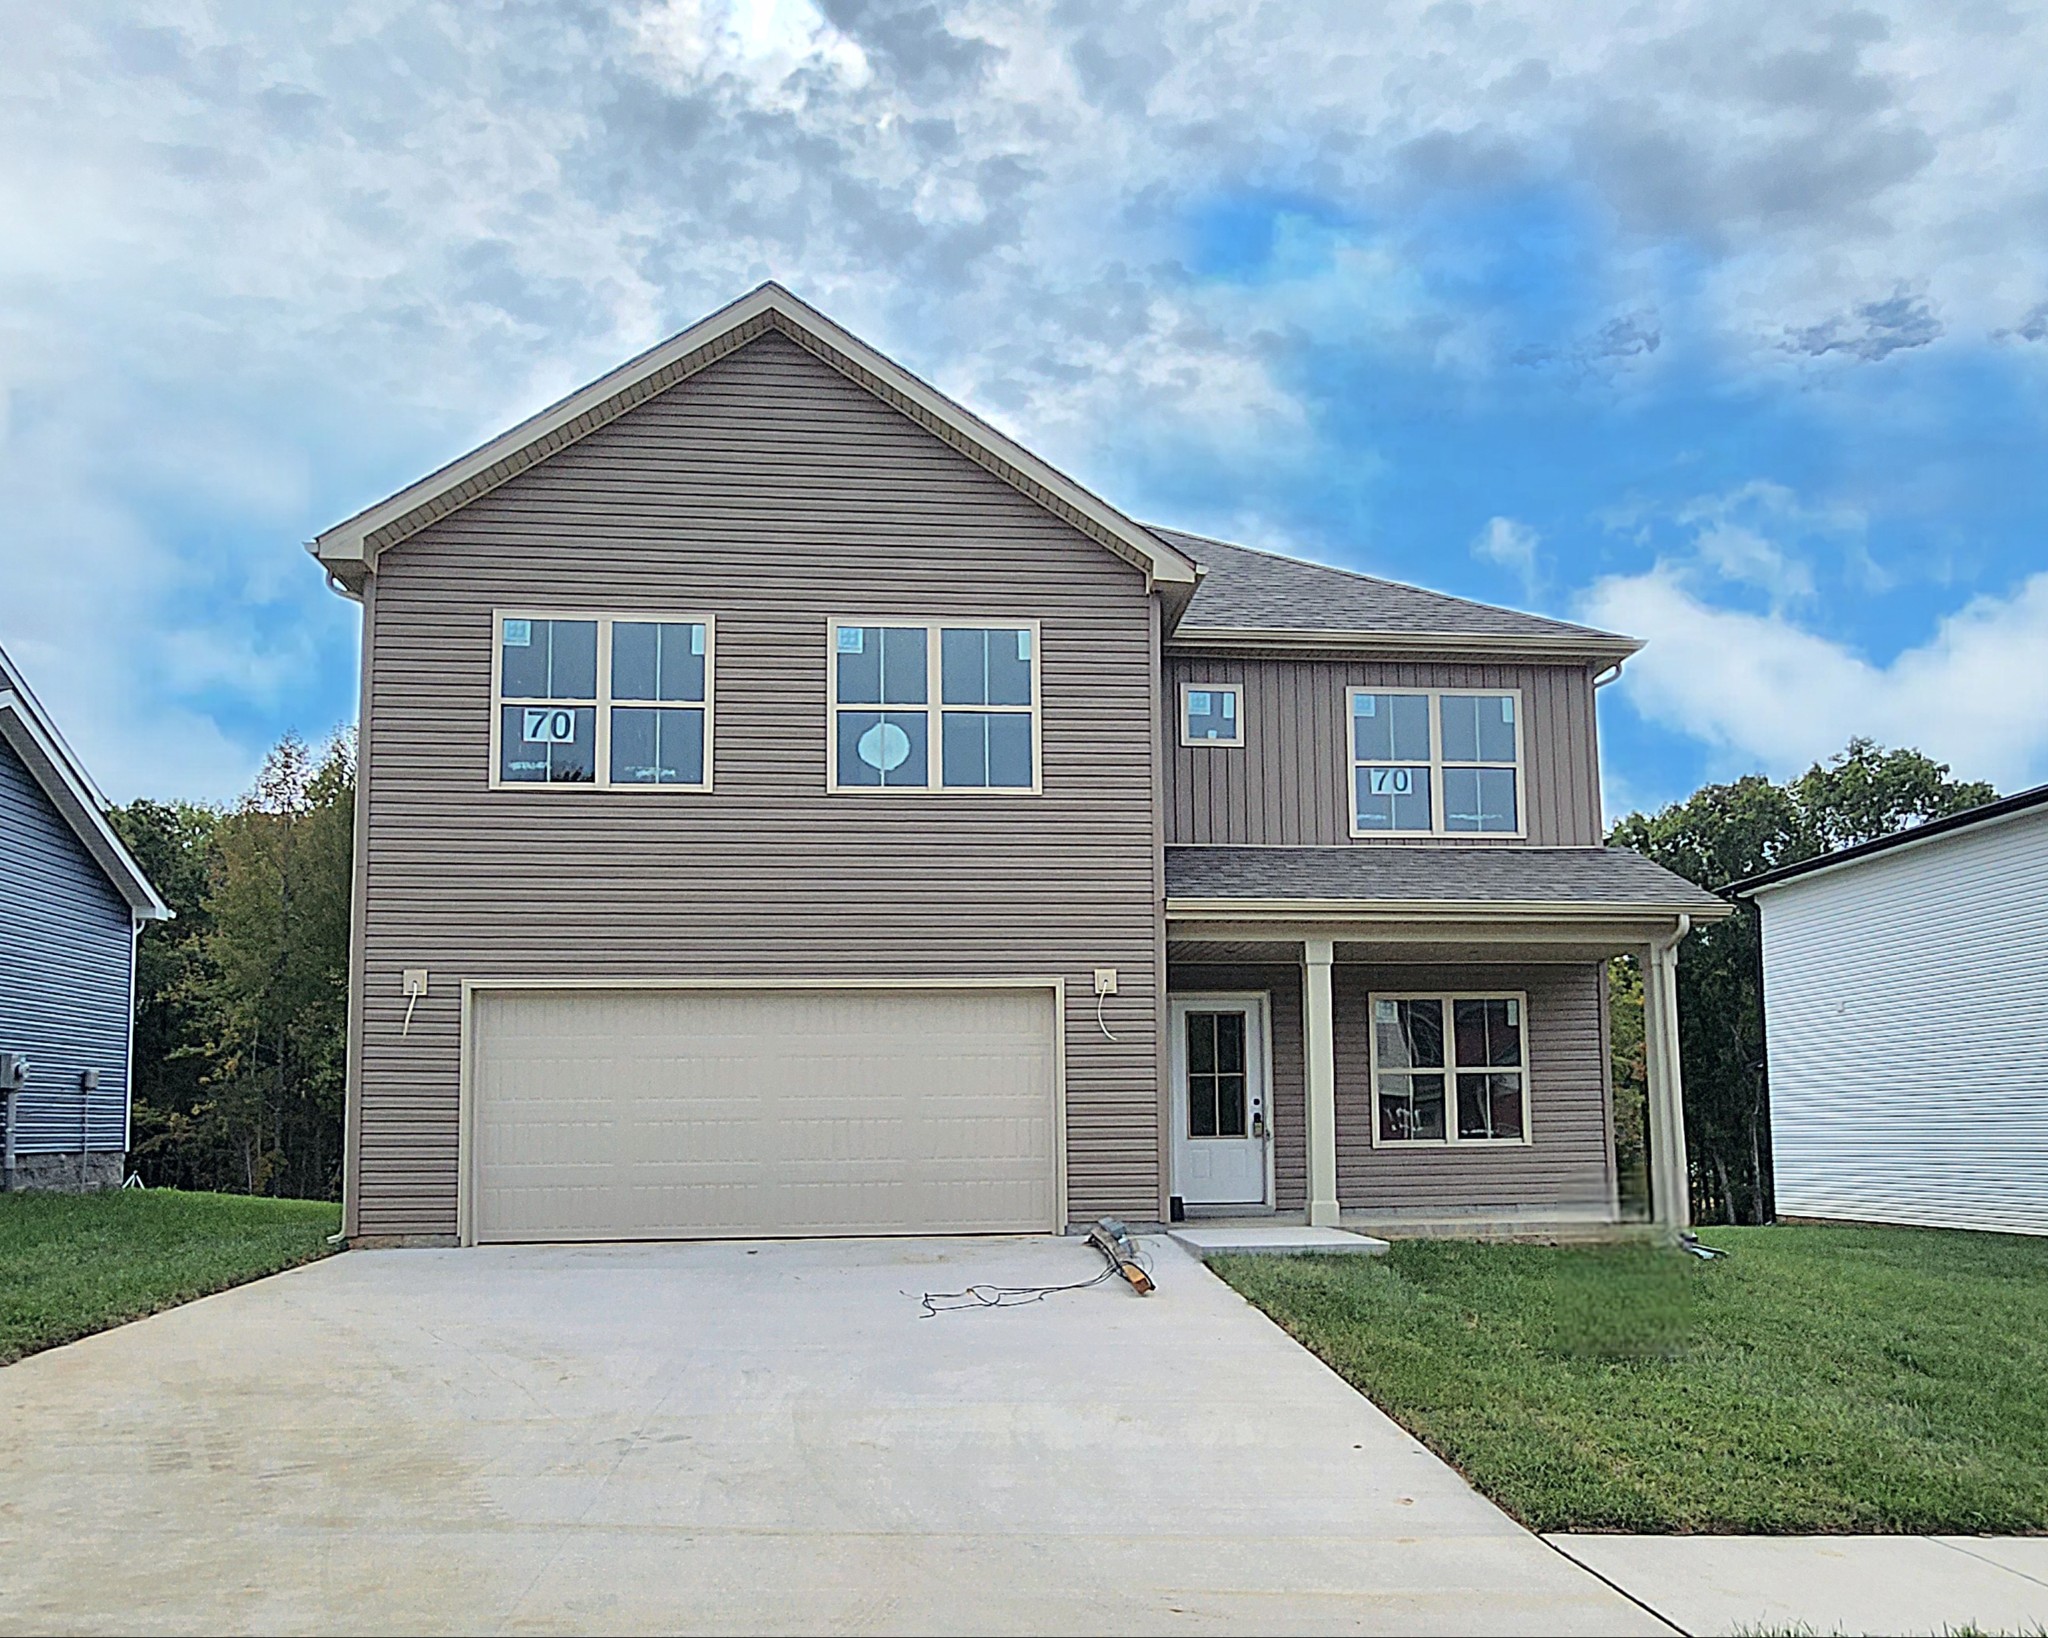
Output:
top-left (827, 620), bottom-right (1038, 792)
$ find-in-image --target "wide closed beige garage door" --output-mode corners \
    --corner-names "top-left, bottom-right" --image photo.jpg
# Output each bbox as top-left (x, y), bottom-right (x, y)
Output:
top-left (471, 989), bottom-right (1061, 1241)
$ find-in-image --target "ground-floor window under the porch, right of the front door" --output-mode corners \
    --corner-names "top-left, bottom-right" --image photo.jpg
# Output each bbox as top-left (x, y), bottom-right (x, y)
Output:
top-left (1372, 993), bottom-right (1530, 1145)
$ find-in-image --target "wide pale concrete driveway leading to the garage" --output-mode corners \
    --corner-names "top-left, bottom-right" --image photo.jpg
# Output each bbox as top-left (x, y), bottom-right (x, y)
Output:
top-left (0, 1239), bottom-right (1665, 1632)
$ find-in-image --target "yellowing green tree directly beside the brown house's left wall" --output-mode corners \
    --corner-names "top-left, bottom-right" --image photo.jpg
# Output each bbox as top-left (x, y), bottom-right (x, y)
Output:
top-left (199, 735), bottom-right (356, 1198)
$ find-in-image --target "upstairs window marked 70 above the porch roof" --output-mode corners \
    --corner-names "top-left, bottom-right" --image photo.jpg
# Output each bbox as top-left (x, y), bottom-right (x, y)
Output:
top-left (1350, 688), bottom-right (1524, 835)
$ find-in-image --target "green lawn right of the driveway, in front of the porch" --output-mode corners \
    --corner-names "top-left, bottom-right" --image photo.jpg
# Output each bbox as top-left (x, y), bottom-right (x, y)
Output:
top-left (1214, 1226), bottom-right (2048, 1532)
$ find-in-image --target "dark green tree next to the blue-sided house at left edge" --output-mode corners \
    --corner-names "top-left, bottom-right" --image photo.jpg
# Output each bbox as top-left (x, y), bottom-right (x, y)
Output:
top-left (109, 801), bottom-right (221, 1188)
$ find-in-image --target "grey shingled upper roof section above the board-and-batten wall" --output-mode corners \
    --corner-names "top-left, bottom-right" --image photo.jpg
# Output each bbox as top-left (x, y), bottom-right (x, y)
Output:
top-left (1153, 526), bottom-right (1642, 661)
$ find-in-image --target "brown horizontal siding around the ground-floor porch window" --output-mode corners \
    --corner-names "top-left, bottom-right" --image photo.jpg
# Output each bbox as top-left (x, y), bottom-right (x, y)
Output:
top-left (1331, 964), bottom-right (1614, 1212)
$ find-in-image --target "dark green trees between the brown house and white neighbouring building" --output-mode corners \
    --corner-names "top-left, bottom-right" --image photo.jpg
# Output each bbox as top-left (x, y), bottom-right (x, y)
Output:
top-left (1608, 739), bottom-right (1997, 1222)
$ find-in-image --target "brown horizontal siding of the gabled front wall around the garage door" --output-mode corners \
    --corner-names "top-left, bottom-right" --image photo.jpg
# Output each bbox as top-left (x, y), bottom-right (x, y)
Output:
top-left (350, 334), bottom-right (1163, 1235)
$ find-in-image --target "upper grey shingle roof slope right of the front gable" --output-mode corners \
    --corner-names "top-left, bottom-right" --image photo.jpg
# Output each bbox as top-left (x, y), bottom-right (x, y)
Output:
top-left (1151, 528), bottom-right (1626, 647)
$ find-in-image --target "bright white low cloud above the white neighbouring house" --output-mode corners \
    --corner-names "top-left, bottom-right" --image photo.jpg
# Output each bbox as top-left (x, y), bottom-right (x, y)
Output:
top-left (1583, 565), bottom-right (2048, 790)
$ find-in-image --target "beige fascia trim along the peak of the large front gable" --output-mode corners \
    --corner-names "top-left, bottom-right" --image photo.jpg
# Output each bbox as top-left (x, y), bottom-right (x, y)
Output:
top-left (309, 283), bottom-right (1198, 588)
